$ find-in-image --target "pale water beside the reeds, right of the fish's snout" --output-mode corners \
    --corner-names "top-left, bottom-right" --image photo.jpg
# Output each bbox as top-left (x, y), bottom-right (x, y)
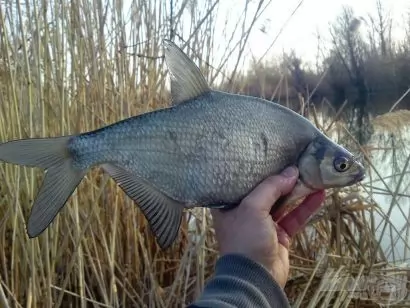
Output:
top-left (363, 127), bottom-right (410, 263)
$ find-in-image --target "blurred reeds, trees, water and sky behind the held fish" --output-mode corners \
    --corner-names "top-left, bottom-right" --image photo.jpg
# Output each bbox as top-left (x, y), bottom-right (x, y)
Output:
top-left (0, 0), bottom-right (410, 307)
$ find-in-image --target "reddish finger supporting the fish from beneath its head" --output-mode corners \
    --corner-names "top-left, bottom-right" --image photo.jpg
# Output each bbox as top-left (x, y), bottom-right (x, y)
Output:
top-left (279, 190), bottom-right (325, 237)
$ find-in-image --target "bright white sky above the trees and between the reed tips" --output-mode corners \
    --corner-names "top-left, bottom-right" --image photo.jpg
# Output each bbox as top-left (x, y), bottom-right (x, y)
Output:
top-left (117, 0), bottom-right (410, 75)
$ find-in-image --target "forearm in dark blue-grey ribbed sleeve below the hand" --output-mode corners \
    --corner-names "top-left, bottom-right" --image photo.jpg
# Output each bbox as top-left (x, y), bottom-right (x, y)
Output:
top-left (188, 255), bottom-right (289, 308)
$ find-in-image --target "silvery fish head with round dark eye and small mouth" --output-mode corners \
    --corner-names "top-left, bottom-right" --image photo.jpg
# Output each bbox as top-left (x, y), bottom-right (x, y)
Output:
top-left (298, 135), bottom-right (366, 190)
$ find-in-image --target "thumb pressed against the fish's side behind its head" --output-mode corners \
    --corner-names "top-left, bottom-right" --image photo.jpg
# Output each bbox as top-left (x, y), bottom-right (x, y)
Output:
top-left (241, 167), bottom-right (299, 212)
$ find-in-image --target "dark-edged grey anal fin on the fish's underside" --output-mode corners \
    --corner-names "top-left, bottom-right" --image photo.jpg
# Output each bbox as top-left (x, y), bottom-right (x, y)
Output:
top-left (102, 164), bottom-right (184, 249)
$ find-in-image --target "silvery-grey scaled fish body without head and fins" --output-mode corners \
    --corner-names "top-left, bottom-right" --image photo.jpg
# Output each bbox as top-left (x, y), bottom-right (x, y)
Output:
top-left (68, 91), bottom-right (320, 207)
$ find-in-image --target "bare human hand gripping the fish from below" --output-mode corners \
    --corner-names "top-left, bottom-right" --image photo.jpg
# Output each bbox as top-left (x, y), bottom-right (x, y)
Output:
top-left (211, 167), bottom-right (324, 288)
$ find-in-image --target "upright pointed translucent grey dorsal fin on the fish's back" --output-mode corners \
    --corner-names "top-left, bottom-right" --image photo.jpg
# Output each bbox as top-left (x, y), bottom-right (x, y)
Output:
top-left (163, 40), bottom-right (211, 105)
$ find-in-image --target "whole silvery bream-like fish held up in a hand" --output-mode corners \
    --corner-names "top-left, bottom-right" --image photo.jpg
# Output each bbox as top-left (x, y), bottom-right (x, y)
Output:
top-left (0, 39), bottom-right (365, 249)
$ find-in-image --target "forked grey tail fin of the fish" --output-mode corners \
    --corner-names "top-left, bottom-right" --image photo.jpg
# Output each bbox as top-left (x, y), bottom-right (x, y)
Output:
top-left (0, 136), bottom-right (87, 238)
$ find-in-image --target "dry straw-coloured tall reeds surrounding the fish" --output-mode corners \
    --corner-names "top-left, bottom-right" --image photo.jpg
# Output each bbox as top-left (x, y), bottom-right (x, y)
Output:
top-left (0, 0), bottom-right (408, 307)
